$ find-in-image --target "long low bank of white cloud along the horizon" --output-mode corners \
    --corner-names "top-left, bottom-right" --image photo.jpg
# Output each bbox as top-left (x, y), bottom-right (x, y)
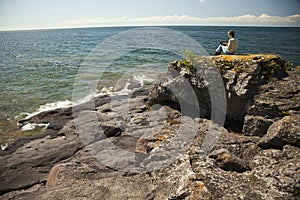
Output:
top-left (0, 14), bottom-right (300, 30)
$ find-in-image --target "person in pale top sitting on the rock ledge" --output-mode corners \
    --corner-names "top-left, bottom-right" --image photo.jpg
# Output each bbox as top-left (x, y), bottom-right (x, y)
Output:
top-left (213, 30), bottom-right (238, 56)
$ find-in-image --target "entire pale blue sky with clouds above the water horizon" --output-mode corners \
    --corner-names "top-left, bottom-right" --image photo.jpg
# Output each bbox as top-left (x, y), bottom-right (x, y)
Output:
top-left (0, 0), bottom-right (300, 30)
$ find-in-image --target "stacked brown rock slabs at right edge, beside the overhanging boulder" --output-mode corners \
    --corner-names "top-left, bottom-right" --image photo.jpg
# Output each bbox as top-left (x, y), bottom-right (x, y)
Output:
top-left (243, 67), bottom-right (300, 136)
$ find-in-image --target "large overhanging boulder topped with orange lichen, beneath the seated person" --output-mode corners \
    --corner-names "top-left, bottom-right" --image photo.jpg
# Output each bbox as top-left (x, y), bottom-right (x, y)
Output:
top-left (149, 55), bottom-right (288, 135)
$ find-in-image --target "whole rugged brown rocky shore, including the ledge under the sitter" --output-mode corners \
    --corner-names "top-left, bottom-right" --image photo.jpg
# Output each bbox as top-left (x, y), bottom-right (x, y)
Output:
top-left (0, 55), bottom-right (300, 200)
